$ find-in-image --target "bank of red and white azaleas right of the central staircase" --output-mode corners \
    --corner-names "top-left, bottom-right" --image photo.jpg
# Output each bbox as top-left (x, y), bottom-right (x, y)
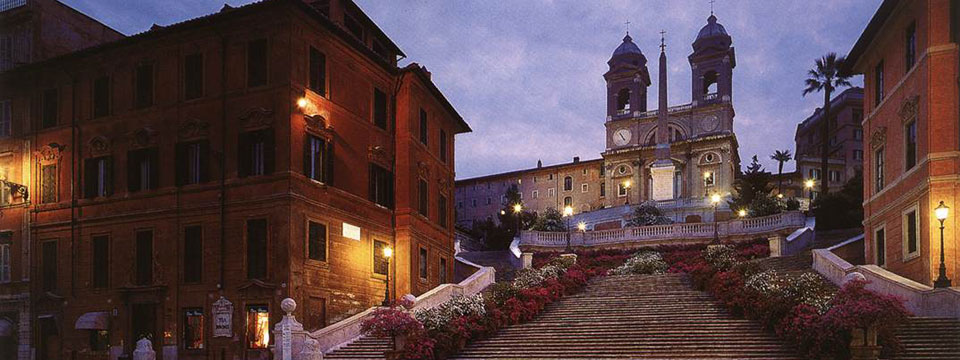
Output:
top-left (659, 240), bottom-right (909, 359)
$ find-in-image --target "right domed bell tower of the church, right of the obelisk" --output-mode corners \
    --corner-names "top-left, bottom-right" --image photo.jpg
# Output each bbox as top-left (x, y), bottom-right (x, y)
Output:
top-left (688, 13), bottom-right (737, 106)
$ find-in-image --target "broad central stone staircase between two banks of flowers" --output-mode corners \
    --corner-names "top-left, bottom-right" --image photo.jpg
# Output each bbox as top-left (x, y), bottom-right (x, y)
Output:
top-left (458, 274), bottom-right (797, 359)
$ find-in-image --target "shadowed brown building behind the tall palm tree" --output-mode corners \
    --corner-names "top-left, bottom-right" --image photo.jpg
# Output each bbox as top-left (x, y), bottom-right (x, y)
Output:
top-left (773, 87), bottom-right (863, 199)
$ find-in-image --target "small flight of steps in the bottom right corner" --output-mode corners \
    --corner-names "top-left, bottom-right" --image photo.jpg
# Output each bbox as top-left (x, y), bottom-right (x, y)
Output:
top-left (895, 317), bottom-right (960, 360)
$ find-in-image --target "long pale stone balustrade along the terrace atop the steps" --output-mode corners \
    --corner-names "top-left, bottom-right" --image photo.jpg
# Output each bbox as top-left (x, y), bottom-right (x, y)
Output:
top-left (520, 211), bottom-right (806, 248)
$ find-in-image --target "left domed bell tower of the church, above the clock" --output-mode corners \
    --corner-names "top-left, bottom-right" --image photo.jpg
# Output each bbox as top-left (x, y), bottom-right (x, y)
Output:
top-left (603, 33), bottom-right (650, 120)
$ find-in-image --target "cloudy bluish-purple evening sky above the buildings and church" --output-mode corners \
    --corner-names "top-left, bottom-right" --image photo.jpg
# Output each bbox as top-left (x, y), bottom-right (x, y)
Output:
top-left (61, 0), bottom-right (880, 179)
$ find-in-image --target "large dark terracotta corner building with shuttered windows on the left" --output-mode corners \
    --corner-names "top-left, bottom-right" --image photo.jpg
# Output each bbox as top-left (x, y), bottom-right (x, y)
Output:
top-left (0, 0), bottom-right (470, 359)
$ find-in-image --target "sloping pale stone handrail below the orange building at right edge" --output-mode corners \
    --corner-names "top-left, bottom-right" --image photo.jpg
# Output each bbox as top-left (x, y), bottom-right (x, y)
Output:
top-left (813, 246), bottom-right (960, 319)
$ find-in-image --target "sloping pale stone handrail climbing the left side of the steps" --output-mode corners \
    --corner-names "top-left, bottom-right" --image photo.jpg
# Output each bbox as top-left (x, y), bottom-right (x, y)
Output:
top-left (307, 258), bottom-right (496, 353)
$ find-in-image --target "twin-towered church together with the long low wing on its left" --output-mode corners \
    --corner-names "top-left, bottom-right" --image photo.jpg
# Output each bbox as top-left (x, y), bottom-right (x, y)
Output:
top-left (456, 15), bottom-right (740, 227)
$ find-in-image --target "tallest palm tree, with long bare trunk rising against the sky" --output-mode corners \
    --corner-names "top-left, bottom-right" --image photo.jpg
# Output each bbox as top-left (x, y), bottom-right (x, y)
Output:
top-left (803, 52), bottom-right (850, 198)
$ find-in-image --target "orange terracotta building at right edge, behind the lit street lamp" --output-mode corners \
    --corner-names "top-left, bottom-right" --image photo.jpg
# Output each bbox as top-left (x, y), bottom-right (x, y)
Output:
top-left (846, 0), bottom-right (960, 285)
